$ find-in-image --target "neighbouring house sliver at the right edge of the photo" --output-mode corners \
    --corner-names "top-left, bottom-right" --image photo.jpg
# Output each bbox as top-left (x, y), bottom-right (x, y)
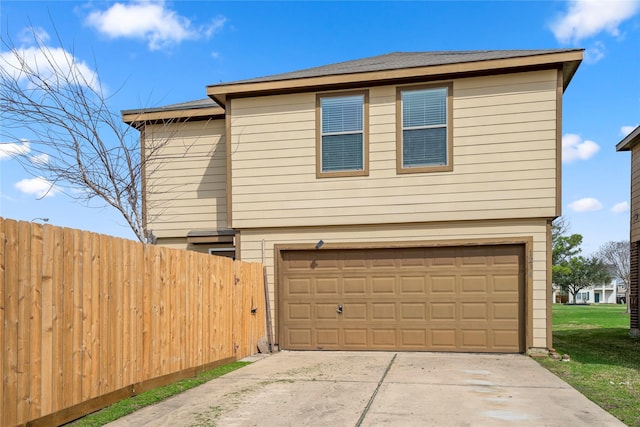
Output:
top-left (616, 126), bottom-right (640, 336)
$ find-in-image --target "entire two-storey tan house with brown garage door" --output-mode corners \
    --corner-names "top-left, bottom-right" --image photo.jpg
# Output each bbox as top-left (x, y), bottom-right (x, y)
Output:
top-left (123, 49), bottom-right (583, 352)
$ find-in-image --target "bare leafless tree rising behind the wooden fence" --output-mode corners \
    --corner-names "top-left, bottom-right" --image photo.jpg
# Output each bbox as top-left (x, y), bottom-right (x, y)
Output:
top-left (0, 29), bottom-right (162, 242)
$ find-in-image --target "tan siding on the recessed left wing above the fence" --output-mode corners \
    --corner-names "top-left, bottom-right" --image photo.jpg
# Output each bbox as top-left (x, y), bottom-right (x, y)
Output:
top-left (145, 120), bottom-right (227, 237)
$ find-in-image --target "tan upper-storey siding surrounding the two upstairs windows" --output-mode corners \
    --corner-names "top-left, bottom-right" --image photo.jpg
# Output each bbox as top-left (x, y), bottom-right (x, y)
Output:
top-left (231, 70), bottom-right (557, 229)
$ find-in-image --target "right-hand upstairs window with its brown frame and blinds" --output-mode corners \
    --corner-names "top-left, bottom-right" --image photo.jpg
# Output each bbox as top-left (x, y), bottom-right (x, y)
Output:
top-left (397, 85), bottom-right (453, 173)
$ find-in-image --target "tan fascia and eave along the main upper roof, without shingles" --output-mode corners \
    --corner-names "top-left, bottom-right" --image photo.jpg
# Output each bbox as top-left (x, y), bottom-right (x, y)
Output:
top-left (207, 50), bottom-right (583, 106)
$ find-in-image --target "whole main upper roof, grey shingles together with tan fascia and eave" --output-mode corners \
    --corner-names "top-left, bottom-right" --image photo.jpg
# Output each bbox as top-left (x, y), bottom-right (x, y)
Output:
top-left (207, 49), bottom-right (584, 106)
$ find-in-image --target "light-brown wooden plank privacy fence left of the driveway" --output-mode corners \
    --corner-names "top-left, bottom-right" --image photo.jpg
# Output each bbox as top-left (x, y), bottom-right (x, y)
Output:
top-left (0, 218), bottom-right (265, 426)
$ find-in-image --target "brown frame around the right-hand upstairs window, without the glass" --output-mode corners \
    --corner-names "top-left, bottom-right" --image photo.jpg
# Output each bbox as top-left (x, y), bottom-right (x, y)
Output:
top-left (396, 82), bottom-right (453, 174)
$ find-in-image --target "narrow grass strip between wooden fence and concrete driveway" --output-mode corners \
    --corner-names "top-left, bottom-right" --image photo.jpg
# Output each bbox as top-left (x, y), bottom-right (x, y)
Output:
top-left (68, 362), bottom-right (250, 427)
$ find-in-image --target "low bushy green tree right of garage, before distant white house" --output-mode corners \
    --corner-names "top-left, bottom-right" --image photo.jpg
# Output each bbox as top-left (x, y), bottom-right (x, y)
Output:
top-left (553, 256), bottom-right (611, 302)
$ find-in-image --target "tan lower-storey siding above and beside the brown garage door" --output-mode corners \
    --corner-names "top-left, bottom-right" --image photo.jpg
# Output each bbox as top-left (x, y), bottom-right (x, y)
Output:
top-left (240, 219), bottom-right (550, 348)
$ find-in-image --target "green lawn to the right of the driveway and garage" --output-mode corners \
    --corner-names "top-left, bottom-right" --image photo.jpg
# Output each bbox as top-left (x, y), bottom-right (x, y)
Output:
top-left (538, 304), bottom-right (640, 426)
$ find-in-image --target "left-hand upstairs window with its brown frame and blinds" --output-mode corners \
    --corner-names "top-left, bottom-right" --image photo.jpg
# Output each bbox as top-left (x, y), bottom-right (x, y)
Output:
top-left (317, 92), bottom-right (369, 177)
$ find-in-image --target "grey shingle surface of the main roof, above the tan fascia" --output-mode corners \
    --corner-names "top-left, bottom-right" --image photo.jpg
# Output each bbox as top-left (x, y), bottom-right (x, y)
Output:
top-left (222, 49), bottom-right (583, 86)
